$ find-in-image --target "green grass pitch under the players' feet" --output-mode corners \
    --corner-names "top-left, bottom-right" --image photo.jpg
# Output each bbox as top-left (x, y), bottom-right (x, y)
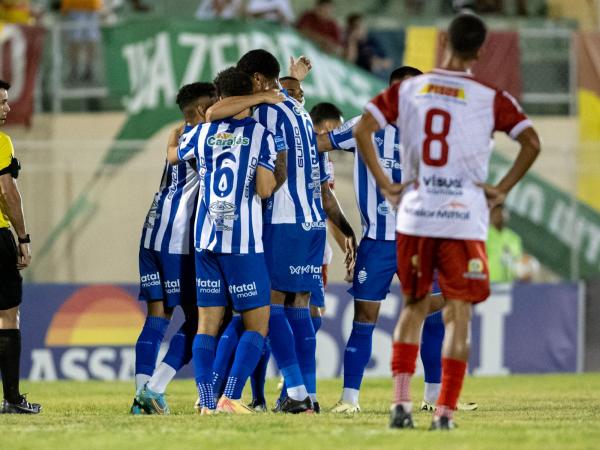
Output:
top-left (0, 374), bottom-right (600, 450)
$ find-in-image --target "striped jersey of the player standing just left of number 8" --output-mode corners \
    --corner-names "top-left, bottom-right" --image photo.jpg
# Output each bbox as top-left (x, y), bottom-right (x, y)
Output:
top-left (329, 117), bottom-right (402, 241)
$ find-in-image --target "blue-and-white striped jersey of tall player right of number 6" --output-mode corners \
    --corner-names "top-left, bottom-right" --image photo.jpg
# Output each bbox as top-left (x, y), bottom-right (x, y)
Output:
top-left (254, 91), bottom-right (329, 224)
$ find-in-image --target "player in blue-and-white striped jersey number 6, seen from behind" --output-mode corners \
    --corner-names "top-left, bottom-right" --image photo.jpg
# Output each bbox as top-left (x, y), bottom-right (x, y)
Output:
top-left (168, 68), bottom-right (283, 414)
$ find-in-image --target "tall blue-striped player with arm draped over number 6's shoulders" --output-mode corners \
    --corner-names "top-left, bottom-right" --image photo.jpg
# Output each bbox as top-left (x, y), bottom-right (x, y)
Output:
top-left (207, 50), bottom-right (356, 413)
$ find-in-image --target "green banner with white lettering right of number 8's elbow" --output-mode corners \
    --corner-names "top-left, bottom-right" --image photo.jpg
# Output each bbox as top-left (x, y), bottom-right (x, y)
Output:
top-left (489, 153), bottom-right (600, 279)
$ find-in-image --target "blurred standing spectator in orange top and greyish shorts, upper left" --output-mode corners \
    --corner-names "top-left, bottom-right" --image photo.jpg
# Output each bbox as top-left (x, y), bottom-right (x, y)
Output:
top-left (60, 0), bottom-right (103, 83)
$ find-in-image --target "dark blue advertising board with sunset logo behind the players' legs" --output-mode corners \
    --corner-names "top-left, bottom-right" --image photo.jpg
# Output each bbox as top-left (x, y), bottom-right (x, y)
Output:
top-left (22, 283), bottom-right (581, 381)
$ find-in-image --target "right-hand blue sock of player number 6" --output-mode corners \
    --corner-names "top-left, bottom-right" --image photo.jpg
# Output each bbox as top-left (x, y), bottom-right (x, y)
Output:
top-left (224, 331), bottom-right (265, 400)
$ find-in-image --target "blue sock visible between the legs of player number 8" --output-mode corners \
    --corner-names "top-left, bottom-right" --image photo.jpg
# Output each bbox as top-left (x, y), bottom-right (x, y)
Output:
top-left (421, 311), bottom-right (445, 383)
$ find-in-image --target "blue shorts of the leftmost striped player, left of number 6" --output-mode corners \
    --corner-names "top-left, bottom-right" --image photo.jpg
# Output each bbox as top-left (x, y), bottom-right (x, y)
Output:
top-left (138, 247), bottom-right (196, 307)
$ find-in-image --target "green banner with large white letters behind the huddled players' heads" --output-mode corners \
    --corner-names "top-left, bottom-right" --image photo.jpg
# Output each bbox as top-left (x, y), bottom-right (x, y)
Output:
top-left (104, 19), bottom-right (385, 149)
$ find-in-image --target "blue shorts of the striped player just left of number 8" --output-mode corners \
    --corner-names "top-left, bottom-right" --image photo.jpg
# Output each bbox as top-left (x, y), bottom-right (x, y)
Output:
top-left (348, 238), bottom-right (440, 301)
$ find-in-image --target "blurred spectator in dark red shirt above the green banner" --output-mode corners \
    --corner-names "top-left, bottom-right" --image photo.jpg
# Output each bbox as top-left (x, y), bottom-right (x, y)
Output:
top-left (296, 0), bottom-right (344, 55)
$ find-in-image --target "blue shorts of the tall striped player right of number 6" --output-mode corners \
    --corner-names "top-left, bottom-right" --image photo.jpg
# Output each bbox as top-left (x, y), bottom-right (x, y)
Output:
top-left (263, 222), bottom-right (327, 292)
